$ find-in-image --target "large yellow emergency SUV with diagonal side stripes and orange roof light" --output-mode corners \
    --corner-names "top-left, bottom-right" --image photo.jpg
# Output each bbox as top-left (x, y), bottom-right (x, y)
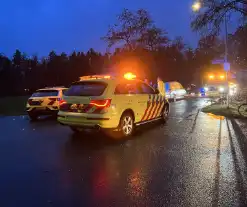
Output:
top-left (58, 73), bottom-right (169, 137)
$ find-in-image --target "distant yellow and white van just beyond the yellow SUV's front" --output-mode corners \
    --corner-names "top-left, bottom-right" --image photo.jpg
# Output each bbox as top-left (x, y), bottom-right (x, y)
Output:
top-left (165, 81), bottom-right (186, 98)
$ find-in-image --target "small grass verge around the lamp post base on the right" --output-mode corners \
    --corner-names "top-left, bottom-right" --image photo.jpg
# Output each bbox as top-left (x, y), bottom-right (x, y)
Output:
top-left (201, 104), bottom-right (243, 118)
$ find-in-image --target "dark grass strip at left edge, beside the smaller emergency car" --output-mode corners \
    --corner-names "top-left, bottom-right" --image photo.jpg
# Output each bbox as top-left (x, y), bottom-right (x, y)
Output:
top-left (0, 96), bottom-right (28, 116)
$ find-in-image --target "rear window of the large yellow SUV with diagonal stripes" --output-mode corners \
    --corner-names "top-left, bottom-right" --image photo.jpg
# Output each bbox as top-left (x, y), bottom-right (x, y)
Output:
top-left (65, 81), bottom-right (107, 96)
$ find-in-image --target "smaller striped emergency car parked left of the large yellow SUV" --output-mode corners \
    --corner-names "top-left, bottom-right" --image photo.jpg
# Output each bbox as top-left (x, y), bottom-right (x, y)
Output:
top-left (26, 87), bottom-right (67, 120)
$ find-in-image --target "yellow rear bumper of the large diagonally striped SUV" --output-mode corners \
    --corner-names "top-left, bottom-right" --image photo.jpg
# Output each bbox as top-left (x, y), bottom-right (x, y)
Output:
top-left (57, 111), bottom-right (119, 129)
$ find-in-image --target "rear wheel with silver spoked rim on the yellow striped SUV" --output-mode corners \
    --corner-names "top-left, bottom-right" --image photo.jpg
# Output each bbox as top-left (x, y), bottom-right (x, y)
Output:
top-left (119, 113), bottom-right (134, 137)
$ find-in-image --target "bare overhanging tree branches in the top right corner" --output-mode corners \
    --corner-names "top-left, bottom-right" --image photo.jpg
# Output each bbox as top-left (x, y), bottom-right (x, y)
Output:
top-left (191, 0), bottom-right (247, 34)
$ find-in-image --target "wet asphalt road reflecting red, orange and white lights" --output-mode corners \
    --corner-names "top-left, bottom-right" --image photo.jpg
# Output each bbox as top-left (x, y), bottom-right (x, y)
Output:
top-left (0, 99), bottom-right (247, 207)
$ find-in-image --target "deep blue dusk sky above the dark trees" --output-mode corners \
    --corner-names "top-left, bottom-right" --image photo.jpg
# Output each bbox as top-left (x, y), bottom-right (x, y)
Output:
top-left (0, 0), bottom-right (198, 56)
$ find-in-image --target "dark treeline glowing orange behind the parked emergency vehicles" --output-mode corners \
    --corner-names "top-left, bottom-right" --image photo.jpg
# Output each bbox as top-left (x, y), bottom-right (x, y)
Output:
top-left (0, 13), bottom-right (247, 96)
